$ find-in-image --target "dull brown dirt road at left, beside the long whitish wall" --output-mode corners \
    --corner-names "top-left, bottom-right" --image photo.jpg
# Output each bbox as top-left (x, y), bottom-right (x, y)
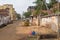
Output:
top-left (0, 21), bottom-right (19, 40)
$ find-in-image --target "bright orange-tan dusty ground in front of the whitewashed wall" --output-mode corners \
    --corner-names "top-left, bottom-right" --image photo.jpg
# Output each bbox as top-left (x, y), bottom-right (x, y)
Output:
top-left (16, 26), bottom-right (55, 34)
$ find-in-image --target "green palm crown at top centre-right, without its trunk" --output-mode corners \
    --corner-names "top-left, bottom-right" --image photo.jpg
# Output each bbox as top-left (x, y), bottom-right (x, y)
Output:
top-left (34, 0), bottom-right (47, 15)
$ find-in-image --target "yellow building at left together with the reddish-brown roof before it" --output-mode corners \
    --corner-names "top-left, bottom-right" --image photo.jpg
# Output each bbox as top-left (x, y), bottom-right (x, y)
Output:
top-left (0, 4), bottom-right (16, 20)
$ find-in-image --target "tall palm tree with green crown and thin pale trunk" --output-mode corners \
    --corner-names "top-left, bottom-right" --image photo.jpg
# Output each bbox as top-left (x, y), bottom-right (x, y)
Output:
top-left (35, 0), bottom-right (45, 26)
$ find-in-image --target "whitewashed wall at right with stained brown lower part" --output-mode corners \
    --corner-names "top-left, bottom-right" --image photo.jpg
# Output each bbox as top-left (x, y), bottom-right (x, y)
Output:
top-left (40, 16), bottom-right (58, 32)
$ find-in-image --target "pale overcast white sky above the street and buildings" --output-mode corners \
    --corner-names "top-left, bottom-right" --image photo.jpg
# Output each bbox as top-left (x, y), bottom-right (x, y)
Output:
top-left (0, 0), bottom-right (59, 14)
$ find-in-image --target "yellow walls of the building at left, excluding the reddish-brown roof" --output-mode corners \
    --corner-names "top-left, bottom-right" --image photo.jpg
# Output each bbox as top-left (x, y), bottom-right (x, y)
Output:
top-left (0, 4), bottom-right (15, 20)
